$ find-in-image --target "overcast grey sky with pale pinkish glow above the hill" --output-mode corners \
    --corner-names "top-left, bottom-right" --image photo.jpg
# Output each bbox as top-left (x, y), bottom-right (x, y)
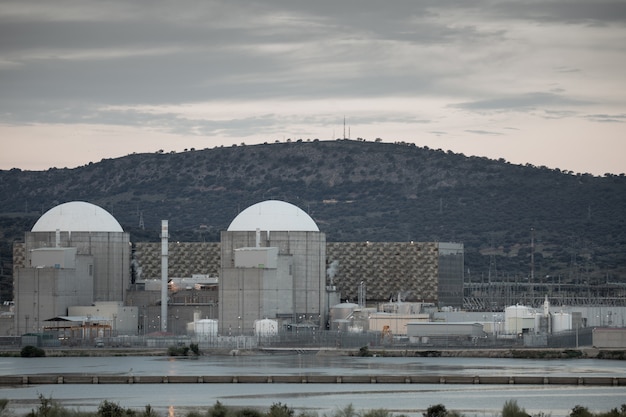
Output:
top-left (0, 0), bottom-right (626, 175)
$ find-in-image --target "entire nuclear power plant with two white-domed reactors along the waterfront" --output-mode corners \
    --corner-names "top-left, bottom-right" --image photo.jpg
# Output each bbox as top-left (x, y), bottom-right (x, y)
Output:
top-left (6, 200), bottom-right (626, 347)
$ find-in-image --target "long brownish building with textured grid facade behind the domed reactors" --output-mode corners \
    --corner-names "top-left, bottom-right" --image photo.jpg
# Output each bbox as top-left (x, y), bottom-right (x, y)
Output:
top-left (135, 239), bottom-right (464, 309)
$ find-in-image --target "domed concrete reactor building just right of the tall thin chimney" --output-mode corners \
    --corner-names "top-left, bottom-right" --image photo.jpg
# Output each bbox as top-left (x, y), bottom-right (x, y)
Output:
top-left (219, 200), bottom-right (327, 335)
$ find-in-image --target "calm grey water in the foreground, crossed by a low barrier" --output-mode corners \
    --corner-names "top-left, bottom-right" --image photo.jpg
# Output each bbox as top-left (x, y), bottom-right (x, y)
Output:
top-left (0, 354), bottom-right (626, 417)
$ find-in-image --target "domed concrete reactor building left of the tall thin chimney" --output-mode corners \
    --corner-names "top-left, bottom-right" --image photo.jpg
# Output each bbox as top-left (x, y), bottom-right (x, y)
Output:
top-left (13, 201), bottom-right (130, 334)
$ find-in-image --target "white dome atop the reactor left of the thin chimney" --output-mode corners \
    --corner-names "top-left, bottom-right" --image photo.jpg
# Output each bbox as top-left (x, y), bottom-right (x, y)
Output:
top-left (31, 201), bottom-right (124, 232)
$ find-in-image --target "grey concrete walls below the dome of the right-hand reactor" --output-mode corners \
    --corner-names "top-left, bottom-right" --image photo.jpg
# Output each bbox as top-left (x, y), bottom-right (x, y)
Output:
top-left (219, 231), bottom-right (327, 335)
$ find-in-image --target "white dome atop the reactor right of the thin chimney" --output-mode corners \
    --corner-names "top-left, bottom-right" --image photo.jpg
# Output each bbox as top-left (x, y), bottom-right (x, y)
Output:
top-left (228, 200), bottom-right (319, 232)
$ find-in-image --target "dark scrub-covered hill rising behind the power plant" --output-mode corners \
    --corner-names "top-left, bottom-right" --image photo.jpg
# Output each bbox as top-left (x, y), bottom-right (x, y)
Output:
top-left (0, 140), bottom-right (626, 299)
